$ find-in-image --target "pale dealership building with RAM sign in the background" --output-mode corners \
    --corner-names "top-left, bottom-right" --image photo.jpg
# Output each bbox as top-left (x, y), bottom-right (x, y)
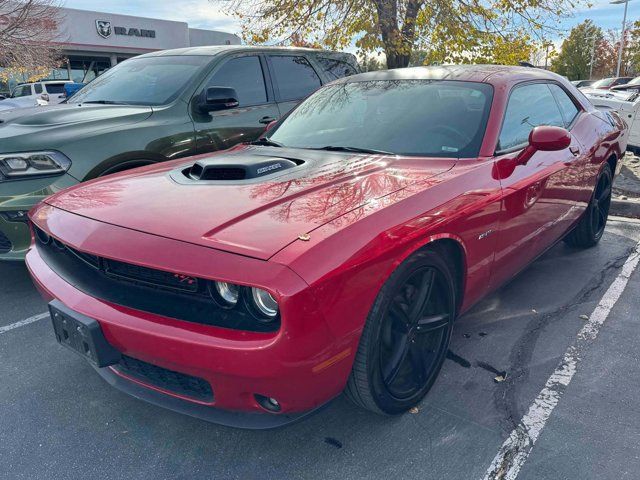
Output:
top-left (3, 6), bottom-right (240, 88)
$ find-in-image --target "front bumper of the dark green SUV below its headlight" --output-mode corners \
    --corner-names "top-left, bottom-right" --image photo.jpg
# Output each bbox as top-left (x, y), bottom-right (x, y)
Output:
top-left (0, 174), bottom-right (78, 261)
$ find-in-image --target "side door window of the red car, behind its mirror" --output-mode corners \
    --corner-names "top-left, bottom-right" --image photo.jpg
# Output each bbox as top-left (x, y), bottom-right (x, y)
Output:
top-left (498, 83), bottom-right (564, 150)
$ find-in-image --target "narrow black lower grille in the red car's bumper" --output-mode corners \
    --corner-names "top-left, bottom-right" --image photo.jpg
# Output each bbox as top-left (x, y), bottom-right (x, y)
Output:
top-left (114, 355), bottom-right (213, 402)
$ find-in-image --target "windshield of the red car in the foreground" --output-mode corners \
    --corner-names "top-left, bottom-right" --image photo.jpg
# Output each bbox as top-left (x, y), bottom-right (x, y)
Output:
top-left (269, 80), bottom-right (493, 157)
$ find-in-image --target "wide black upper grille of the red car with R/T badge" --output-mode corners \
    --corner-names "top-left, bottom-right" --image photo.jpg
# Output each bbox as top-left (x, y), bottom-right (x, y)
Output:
top-left (34, 225), bottom-right (280, 332)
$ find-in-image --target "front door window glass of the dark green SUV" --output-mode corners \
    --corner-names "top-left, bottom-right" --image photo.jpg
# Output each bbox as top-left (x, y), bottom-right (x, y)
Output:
top-left (207, 56), bottom-right (267, 107)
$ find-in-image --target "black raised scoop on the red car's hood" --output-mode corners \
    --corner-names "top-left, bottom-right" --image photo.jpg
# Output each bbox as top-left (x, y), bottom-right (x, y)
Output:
top-left (188, 155), bottom-right (304, 181)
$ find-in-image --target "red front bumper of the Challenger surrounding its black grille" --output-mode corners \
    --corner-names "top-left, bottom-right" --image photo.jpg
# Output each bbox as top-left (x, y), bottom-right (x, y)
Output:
top-left (26, 207), bottom-right (354, 428)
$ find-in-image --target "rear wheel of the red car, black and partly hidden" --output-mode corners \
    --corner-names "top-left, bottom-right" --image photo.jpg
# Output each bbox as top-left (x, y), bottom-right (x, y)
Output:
top-left (564, 163), bottom-right (612, 248)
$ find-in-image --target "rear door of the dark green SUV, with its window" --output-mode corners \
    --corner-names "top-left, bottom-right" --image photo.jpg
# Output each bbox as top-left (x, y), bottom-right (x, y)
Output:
top-left (267, 53), bottom-right (322, 115)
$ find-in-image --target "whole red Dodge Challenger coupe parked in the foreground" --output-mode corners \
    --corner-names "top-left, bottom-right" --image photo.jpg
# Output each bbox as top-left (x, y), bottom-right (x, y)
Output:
top-left (27, 66), bottom-right (626, 428)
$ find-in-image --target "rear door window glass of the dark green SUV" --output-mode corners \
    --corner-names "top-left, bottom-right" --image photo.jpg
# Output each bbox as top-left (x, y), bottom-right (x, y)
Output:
top-left (270, 55), bottom-right (320, 101)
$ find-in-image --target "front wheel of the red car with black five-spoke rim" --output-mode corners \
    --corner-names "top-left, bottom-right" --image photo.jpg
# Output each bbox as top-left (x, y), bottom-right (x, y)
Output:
top-left (345, 249), bottom-right (456, 415)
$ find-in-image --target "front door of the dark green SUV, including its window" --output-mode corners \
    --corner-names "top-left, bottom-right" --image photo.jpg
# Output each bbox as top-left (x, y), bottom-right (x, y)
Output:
top-left (192, 54), bottom-right (280, 153)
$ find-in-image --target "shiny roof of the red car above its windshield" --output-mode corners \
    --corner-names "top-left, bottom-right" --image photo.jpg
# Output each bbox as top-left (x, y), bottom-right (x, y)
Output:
top-left (334, 65), bottom-right (566, 84)
